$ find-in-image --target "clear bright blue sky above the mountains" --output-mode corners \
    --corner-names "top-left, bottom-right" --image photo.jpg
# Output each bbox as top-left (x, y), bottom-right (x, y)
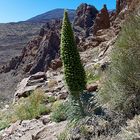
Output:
top-left (0, 0), bottom-right (116, 23)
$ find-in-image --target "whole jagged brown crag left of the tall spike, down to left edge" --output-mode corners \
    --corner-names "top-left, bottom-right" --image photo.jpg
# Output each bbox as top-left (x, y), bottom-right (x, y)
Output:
top-left (0, 20), bottom-right (61, 74)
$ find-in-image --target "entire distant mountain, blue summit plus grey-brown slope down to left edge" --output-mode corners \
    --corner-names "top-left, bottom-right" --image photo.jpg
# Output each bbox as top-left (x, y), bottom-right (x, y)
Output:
top-left (0, 9), bottom-right (75, 65)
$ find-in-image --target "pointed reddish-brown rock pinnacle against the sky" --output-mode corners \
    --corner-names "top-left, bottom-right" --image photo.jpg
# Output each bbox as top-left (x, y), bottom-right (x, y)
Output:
top-left (93, 5), bottom-right (110, 35)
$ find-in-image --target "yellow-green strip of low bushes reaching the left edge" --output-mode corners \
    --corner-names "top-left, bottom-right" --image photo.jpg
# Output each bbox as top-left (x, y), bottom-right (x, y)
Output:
top-left (0, 90), bottom-right (50, 130)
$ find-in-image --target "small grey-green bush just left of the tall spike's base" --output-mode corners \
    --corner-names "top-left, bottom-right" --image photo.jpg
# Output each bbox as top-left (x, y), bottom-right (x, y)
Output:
top-left (51, 101), bottom-right (67, 122)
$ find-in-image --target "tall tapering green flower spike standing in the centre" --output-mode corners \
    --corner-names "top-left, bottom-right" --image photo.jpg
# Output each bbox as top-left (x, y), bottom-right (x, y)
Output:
top-left (61, 11), bottom-right (86, 94)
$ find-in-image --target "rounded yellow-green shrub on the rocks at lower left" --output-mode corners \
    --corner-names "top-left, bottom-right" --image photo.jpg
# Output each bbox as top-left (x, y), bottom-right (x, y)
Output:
top-left (15, 91), bottom-right (50, 120)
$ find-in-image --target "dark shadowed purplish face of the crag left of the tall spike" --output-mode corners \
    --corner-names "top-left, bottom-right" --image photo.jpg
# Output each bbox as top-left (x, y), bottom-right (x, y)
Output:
top-left (30, 31), bottom-right (60, 74)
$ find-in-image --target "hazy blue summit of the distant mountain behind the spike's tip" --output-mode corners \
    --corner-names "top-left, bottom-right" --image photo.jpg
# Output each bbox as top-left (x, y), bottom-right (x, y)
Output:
top-left (26, 8), bottom-right (75, 22)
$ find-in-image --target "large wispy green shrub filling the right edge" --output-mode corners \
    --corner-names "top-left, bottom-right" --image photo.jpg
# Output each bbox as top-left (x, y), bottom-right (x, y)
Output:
top-left (98, 16), bottom-right (140, 117)
